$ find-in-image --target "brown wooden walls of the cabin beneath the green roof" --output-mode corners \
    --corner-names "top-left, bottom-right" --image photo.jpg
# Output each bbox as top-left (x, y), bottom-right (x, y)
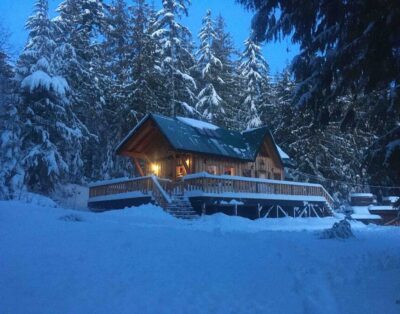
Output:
top-left (121, 120), bottom-right (284, 180)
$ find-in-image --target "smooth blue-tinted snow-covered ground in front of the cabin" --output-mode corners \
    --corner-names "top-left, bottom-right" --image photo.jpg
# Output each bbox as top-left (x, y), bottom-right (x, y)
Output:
top-left (0, 197), bottom-right (400, 313)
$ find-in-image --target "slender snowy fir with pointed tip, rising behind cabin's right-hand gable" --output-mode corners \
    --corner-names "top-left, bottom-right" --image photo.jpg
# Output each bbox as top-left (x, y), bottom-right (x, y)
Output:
top-left (240, 38), bottom-right (268, 129)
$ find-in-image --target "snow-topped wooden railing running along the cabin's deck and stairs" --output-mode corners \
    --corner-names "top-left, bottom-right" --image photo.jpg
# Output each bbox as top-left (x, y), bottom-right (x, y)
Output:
top-left (89, 173), bottom-right (334, 208)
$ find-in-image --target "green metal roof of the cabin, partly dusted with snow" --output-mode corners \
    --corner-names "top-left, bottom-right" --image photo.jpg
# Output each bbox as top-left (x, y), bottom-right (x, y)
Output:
top-left (117, 114), bottom-right (280, 166)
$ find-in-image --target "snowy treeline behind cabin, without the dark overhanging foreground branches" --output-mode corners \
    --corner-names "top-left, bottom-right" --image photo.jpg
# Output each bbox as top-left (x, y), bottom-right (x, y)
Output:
top-left (0, 0), bottom-right (399, 198)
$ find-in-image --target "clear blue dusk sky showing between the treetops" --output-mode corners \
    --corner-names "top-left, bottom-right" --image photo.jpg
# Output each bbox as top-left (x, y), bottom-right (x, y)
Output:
top-left (0, 0), bottom-right (298, 75)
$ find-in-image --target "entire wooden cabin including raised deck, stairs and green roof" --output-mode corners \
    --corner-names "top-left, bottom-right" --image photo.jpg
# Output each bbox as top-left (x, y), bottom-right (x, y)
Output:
top-left (89, 114), bottom-right (333, 219)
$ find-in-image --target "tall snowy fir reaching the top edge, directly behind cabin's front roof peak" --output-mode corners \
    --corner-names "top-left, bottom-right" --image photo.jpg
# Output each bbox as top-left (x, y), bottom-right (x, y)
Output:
top-left (152, 0), bottom-right (197, 116)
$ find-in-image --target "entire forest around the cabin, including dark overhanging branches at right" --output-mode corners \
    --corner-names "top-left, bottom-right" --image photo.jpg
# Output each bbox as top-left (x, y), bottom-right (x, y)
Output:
top-left (0, 0), bottom-right (400, 199)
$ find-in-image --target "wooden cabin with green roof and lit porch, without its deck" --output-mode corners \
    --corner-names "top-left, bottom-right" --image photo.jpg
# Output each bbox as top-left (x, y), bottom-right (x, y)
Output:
top-left (117, 114), bottom-right (284, 180)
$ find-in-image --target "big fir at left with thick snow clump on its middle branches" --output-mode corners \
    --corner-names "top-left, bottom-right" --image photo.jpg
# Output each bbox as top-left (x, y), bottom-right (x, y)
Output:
top-left (16, 0), bottom-right (83, 193)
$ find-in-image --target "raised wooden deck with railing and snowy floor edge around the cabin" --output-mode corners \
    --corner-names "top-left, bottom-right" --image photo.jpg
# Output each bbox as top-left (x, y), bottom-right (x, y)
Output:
top-left (89, 173), bottom-right (334, 217)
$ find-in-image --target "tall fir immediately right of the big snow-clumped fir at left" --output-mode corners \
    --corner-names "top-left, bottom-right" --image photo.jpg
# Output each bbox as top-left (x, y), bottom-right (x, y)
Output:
top-left (55, 0), bottom-right (108, 178)
